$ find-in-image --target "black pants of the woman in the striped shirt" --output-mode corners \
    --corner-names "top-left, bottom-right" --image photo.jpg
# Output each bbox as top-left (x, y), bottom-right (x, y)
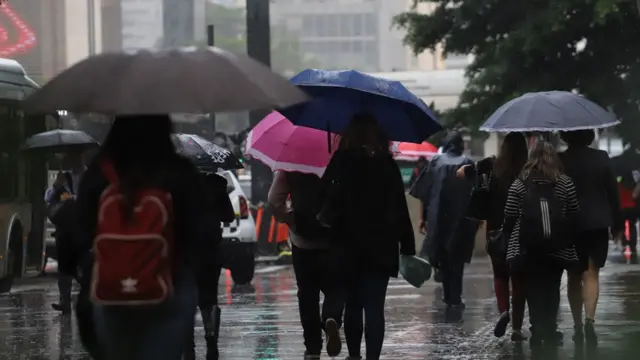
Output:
top-left (522, 259), bottom-right (564, 339)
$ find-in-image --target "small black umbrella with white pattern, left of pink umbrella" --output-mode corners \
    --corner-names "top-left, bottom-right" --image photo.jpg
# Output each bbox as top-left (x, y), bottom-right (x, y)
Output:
top-left (173, 134), bottom-right (243, 171)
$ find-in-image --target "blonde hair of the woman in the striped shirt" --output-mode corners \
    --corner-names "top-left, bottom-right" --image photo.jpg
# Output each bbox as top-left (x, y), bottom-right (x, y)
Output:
top-left (520, 140), bottom-right (562, 181)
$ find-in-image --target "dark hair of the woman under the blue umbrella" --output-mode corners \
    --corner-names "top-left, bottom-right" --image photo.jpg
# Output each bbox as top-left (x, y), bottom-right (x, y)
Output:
top-left (339, 113), bottom-right (391, 154)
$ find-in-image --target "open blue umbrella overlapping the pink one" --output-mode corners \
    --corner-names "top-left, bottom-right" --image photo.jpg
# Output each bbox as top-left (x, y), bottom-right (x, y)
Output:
top-left (279, 69), bottom-right (442, 143)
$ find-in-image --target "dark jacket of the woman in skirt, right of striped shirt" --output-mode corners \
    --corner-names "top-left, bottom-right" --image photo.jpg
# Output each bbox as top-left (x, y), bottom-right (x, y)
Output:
top-left (559, 146), bottom-right (623, 232)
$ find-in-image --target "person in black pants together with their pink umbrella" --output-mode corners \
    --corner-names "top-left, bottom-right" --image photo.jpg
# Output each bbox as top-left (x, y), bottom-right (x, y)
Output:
top-left (246, 112), bottom-right (344, 359)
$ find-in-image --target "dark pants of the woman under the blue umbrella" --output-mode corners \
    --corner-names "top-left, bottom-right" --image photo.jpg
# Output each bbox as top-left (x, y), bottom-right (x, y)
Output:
top-left (344, 272), bottom-right (389, 360)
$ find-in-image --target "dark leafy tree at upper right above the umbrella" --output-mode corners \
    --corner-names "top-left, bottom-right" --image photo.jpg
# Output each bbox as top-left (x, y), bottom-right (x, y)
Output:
top-left (395, 0), bottom-right (640, 145)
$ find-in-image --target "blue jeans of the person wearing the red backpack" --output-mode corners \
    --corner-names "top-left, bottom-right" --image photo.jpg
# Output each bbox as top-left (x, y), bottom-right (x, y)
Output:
top-left (93, 270), bottom-right (198, 360)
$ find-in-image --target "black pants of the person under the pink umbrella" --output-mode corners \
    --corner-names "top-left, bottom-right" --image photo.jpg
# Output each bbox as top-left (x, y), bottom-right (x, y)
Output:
top-left (292, 246), bottom-right (344, 355)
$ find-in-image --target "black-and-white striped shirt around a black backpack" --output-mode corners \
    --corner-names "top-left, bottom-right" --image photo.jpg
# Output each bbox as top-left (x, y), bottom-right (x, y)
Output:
top-left (503, 175), bottom-right (580, 262)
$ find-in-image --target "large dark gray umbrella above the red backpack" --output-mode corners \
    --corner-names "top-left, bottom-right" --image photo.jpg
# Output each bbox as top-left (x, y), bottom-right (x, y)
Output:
top-left (25, 47), bottom-right (307, 115)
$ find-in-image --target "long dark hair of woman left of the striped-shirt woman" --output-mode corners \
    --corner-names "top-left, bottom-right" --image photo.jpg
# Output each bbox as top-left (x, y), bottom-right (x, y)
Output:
top-left (493, 132), bottom-right (528, 184)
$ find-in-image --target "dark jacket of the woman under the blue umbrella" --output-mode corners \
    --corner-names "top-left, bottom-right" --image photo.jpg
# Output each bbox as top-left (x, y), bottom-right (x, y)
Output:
top-left (323, 149), bottom-right (415, 277)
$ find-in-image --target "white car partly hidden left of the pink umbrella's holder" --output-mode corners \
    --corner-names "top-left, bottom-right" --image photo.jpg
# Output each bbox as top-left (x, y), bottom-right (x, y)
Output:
top-left (218, 171), bottom-right (257, 285)
